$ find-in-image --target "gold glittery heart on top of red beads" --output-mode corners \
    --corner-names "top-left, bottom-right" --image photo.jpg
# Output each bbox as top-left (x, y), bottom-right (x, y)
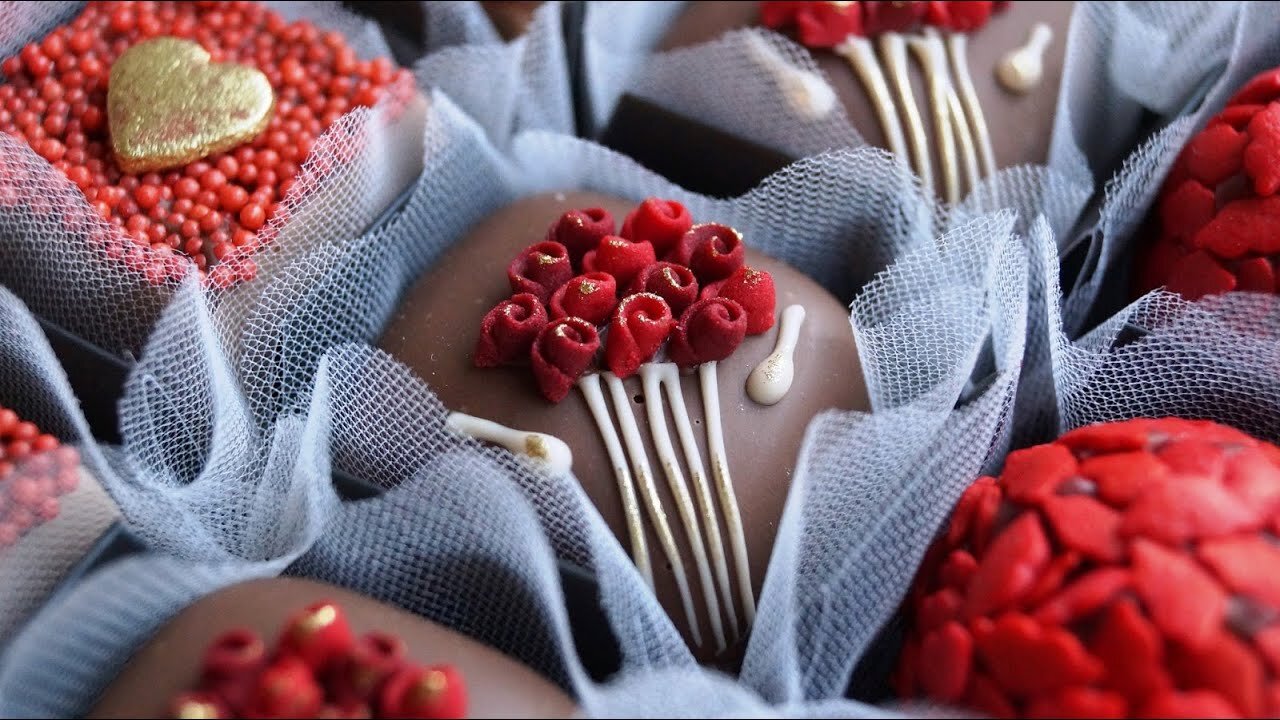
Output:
top-left (106, 37), bottom-right (275, 173)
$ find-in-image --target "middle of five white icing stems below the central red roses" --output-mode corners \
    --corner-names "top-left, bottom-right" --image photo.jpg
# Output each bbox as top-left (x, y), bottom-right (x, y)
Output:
top-left (640, 363), bottom-right (732, 652)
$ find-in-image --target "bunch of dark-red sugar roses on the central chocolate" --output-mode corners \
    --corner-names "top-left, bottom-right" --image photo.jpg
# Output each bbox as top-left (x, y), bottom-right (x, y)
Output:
top-left (474, 197), bottom-right (776, 402)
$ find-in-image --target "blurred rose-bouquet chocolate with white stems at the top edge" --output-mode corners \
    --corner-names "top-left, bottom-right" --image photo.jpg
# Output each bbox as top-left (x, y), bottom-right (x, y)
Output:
top-left (659, 1), bottom-right (1074, 201)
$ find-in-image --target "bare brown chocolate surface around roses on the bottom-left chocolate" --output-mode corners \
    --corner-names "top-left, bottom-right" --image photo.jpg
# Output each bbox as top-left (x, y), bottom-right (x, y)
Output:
top-left (90, 578), bottom-right (575, 717)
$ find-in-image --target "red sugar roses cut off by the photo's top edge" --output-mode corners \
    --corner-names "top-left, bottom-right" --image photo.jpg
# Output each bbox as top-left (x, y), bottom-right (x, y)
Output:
top-left (760, 0), bottom-right (1009, 47)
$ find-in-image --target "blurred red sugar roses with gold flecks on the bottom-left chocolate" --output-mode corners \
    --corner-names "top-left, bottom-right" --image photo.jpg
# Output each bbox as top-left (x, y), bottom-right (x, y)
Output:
top-left (172, 602), bottom-right (467, 719)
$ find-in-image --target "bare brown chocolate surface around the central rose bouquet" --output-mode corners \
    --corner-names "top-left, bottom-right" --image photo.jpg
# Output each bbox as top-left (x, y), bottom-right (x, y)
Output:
top-left (379, 192), bottom-right (868, 657)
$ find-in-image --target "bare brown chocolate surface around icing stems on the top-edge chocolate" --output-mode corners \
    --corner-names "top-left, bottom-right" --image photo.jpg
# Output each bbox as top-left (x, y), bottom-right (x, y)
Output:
top-left (659, 0), bottom-right (1074, 182)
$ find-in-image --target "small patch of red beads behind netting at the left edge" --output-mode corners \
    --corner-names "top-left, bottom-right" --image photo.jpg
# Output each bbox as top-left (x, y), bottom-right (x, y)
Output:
top-left (0, 406), bottom-right (79, 551)
